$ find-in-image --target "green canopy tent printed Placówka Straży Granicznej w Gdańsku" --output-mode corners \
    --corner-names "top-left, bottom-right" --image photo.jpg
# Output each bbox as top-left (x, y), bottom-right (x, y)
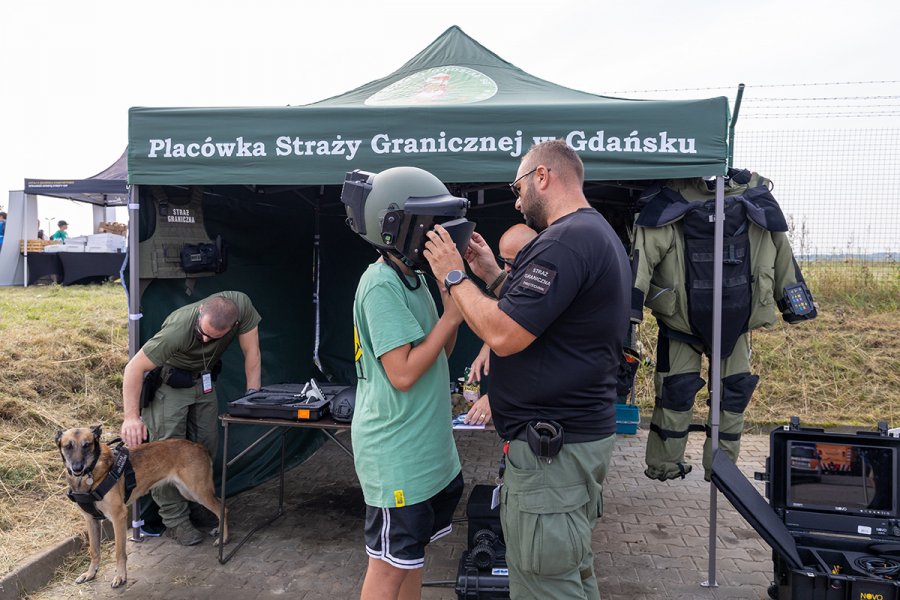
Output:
top-left (128, 27), bottom-right (729, 506)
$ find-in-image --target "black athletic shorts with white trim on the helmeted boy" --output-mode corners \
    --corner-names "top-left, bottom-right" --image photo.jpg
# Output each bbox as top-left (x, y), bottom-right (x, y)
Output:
top-left (364, 471), bottom-right (463, 569)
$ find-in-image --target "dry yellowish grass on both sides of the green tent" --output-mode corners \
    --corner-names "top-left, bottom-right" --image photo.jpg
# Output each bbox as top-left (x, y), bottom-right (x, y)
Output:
top-left (0, 265), bottom-right (900, 575)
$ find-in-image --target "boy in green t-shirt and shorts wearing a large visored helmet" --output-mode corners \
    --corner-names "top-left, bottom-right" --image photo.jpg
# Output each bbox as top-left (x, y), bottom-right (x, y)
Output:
top-left (341, 167), bottom-right (465, 600)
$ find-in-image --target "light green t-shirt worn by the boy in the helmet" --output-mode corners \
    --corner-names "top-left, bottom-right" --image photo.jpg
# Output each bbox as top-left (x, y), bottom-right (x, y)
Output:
top-left (351, 262), bottom-right (460, 508)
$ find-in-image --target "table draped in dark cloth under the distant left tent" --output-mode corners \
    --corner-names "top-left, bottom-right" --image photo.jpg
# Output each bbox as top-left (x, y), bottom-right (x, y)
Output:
top-left (27, 252), bottom-right (125, 285)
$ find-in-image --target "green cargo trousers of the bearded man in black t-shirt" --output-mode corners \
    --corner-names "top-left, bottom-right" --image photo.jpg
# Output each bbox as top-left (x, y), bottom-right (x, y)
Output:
top-left (500, 435), bottom-right (616, 600)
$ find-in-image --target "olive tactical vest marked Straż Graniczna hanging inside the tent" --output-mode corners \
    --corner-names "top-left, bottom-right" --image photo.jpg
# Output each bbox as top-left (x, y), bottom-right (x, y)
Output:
top-left (139, 186), bottom-right (225, 279)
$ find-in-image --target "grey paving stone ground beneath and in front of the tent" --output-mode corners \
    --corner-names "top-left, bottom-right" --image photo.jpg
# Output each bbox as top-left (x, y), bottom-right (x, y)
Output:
top-left (39, 429), bottom-right (772, 600)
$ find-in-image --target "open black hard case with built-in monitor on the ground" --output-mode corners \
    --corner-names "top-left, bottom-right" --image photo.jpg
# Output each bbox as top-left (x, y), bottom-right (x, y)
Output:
top-left (712, 425), bottom-right (900, 600)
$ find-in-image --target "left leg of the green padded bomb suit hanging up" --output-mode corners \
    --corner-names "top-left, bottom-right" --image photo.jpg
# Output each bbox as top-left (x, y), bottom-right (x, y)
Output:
top-left (644, 336), bottom-right (706, 481)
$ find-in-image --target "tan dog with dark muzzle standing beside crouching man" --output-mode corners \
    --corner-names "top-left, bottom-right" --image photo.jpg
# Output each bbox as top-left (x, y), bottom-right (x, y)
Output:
top-left (56, 425), bottom-right (228, 588)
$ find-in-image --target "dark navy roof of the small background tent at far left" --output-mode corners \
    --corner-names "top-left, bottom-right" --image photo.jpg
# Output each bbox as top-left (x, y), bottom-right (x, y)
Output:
top-left (25, 150), bottom-right (128, 206)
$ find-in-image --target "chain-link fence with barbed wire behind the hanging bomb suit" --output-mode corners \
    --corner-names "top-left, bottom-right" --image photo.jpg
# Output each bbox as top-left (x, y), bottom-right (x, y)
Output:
top-left (609, 80), bottom-right (900, 291)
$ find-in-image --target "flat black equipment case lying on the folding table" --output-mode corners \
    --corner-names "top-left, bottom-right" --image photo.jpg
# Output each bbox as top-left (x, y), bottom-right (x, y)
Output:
top-left (228, 383), bottom-right (351, 421)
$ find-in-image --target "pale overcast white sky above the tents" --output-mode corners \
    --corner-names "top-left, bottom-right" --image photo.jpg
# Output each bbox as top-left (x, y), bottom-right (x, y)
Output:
top-left (0, 0), bottom-right (900, 247)
